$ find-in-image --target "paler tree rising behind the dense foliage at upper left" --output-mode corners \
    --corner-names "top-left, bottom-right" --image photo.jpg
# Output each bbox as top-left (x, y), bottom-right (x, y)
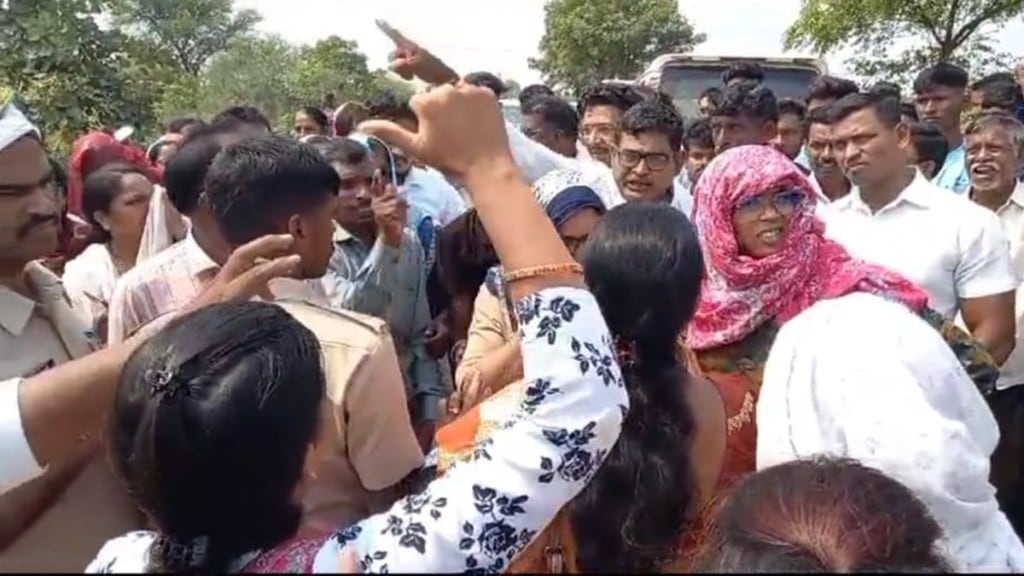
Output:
top-left (110, 0), bottom-right (260, 77)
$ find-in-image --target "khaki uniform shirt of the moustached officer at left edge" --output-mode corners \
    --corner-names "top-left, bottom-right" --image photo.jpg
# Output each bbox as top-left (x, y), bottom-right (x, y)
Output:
top-left (0, 263), bottom-right (141, 573)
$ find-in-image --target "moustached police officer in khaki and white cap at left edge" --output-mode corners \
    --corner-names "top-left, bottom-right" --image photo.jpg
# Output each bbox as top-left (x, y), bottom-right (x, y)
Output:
top-left (0, 100), bottom-right (141, 572)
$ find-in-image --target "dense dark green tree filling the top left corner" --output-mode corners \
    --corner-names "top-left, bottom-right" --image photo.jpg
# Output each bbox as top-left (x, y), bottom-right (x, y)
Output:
top-left (0, 0), bottom-right (157, 152)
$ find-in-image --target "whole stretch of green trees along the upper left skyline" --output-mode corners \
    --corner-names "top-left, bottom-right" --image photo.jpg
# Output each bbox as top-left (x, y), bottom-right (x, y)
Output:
top-left (0, 0), bottom-right (412, 151)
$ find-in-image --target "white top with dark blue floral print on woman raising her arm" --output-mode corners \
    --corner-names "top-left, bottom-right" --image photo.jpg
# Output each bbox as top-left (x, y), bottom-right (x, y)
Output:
top-left (86, 287), bottom-right (629, 573)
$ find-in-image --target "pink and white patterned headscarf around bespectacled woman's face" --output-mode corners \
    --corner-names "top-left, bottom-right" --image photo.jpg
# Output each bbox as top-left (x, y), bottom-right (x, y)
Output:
top-left (686, 146), bottom-right (928, 351)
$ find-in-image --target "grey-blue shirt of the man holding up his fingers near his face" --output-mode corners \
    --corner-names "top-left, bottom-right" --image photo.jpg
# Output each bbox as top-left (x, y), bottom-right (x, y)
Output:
top-left (322, 227), bottom-right (447, 421)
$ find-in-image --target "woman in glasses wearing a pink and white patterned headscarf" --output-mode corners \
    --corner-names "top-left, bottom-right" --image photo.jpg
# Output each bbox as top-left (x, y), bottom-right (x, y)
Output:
top-left (685, 146), bottom-right (998, 494)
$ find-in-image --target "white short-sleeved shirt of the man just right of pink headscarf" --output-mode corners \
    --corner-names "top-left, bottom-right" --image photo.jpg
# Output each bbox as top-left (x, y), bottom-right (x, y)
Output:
top-left (824, 171), bottom-right (1020, 319)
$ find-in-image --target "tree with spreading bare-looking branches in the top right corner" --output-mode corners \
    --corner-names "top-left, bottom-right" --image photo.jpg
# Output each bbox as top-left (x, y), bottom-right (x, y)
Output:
top-left (785, 0), bottom-right (1024, 82)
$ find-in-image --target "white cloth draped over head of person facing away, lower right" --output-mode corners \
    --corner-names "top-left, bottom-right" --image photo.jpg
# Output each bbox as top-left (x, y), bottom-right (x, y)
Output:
top-left (757, 291), bottom-right (1024, 572)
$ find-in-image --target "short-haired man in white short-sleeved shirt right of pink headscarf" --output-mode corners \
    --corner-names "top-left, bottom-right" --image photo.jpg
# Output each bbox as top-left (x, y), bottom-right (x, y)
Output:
top-left (825, 93), bottom-right (1020, 364)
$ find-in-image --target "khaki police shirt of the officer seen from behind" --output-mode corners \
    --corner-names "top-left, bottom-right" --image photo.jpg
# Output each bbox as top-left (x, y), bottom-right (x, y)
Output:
top-left (276, 299), bottom-right (423, 531)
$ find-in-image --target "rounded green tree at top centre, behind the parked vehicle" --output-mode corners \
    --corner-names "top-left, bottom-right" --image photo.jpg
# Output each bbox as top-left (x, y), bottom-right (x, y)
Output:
top-left (530, 0), bottom-right (705, 92)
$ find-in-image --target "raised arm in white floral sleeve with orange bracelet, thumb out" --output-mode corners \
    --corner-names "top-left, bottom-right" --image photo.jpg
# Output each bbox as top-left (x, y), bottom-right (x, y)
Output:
top-left (323, 80), bottom-right (628, 572)
